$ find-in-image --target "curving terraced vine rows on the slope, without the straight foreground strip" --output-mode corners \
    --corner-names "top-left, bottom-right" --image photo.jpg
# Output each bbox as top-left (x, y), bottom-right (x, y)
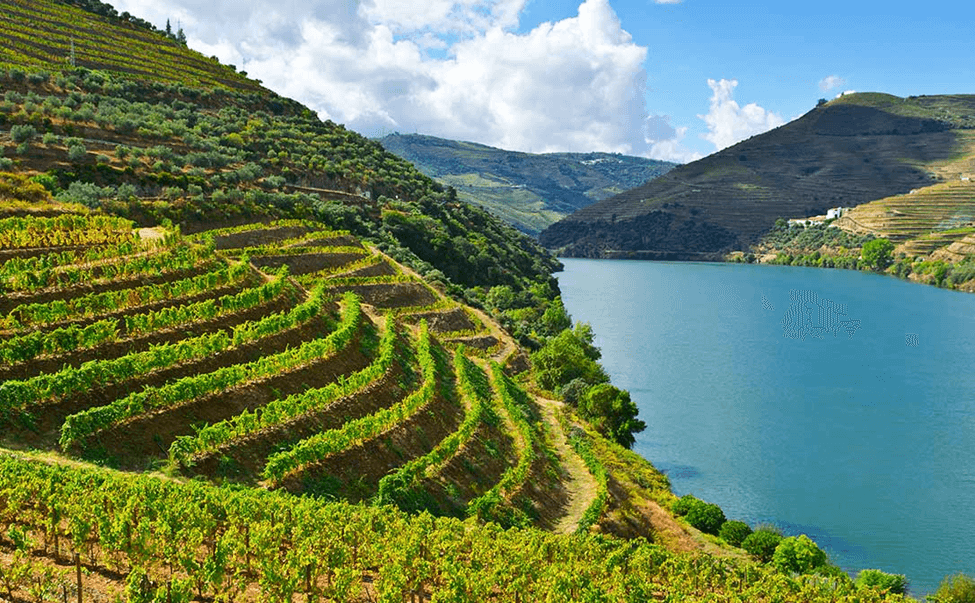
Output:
top-left (0, 205), bottom-right (608, 525)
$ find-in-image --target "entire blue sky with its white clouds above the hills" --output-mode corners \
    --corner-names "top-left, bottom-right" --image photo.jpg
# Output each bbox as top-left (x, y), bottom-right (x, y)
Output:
top-left (110, 0), bottom-right (975, 163)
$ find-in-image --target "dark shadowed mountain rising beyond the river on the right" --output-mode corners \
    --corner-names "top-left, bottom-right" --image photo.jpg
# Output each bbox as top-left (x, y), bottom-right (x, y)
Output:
top-left (540, 93), bottom-right (975, 260)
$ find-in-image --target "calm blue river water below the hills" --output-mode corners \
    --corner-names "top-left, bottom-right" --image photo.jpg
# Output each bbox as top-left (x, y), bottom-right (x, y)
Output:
top-left (557, 259), bottom-right (975, 596)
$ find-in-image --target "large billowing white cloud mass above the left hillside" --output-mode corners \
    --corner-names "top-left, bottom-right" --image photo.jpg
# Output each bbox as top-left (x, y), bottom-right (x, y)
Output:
top-left (108, 0), bottom-right (696, 160)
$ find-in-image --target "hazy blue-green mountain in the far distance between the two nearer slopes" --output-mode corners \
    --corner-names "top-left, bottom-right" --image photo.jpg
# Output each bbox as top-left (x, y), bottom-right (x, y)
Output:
top-left (379, 134), bottom-right (677, 235)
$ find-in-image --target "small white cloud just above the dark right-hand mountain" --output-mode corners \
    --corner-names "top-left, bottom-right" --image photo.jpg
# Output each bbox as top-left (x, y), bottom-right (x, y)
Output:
top-left (698, 79), bottom-right (785, 151)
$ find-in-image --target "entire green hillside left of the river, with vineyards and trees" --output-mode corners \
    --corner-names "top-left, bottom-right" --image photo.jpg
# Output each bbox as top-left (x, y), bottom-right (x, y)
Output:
top-left (0, 0), bottom-right (924, 603)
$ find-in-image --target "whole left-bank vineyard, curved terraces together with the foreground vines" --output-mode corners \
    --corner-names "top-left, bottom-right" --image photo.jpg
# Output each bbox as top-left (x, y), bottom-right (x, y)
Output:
top-left (0, 206), bottom-right (916, 601)
